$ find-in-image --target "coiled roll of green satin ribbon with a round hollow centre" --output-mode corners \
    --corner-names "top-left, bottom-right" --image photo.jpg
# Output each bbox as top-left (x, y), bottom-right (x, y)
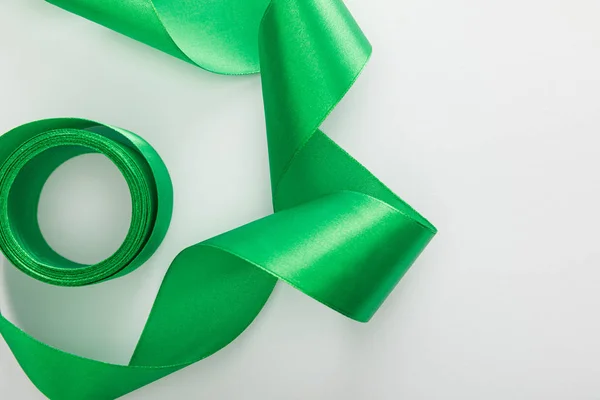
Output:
top-left (0, 119), bottom-right (173, 286)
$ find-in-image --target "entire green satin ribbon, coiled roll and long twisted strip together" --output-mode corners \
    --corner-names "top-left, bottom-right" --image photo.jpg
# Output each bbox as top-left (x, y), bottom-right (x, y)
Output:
top-left (0, 0), bottom-right (436, 400)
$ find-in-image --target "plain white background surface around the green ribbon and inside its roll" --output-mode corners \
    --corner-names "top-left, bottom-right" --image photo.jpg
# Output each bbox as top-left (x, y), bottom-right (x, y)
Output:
top-left (0, 0), bottom-right (600, 400)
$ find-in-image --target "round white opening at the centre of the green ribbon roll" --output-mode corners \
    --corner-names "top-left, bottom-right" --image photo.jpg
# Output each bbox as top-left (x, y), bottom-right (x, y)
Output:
top-left (37, 154), bottom-right (131, 264)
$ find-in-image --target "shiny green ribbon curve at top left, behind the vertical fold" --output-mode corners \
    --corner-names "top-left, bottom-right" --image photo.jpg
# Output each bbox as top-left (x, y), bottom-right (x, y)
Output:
top-left (47, 0), bottom-right (268, 75)
